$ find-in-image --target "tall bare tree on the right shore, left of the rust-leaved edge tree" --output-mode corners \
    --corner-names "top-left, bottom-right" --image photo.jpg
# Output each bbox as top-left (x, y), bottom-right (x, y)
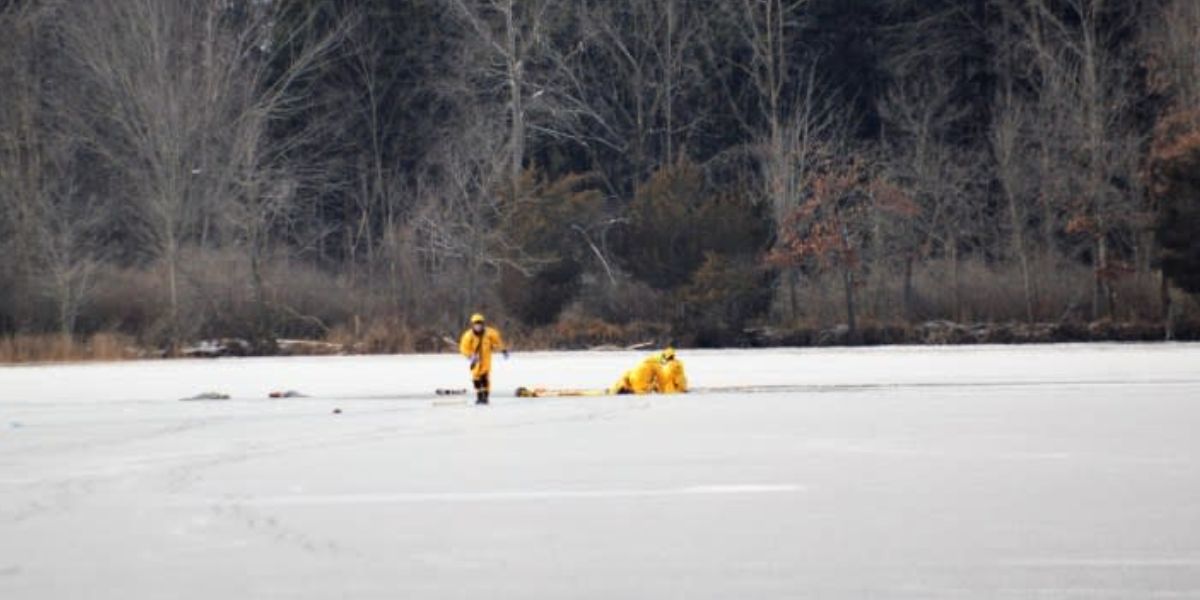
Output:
top-left (997, 0), bottom-right (1144, 318)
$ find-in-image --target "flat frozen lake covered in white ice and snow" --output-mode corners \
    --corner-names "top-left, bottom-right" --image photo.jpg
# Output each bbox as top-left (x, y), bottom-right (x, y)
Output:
top-left (0, 344), bottom-right (1200, 600)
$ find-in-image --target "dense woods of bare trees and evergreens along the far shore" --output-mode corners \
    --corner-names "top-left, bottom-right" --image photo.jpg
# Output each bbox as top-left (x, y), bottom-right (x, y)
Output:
top-left (0, 0), bottom-right (1200, 352)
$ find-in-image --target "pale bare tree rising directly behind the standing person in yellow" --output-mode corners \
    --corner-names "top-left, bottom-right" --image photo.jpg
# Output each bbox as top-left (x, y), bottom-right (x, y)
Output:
top-left (432, 0), bottom-right (638, 319)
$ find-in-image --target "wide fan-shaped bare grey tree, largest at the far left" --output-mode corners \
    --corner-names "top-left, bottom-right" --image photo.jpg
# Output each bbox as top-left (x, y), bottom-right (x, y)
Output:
top-left (62, 0), bottom-right (230, 343)
